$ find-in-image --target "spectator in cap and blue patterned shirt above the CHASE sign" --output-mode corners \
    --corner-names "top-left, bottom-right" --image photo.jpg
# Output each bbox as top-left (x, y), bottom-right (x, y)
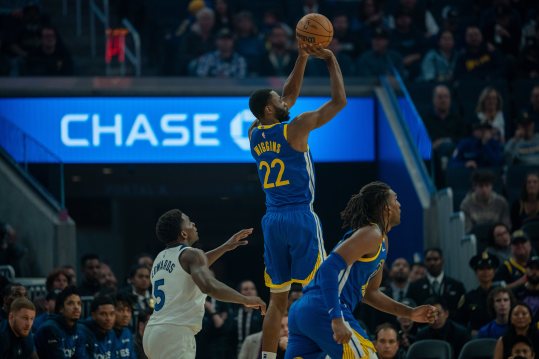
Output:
top-left (189, 28), bottom-right (247, 79)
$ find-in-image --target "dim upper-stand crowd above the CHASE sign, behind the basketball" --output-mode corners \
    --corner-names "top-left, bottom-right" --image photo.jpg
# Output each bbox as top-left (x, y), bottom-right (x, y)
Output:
top-left (0, 0), bottom-right (539, 81)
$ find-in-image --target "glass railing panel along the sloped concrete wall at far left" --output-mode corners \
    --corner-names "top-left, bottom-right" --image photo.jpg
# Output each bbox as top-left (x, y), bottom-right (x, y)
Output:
top-left (0, 117), bottom-right (65, 210)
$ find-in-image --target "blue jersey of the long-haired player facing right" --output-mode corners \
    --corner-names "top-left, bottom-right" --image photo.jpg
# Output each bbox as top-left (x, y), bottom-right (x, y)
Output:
top-left (304, 231), bottom-right (387, 311)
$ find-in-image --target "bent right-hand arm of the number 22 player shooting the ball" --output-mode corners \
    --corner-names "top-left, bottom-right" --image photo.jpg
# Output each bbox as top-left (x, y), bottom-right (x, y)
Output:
top-left (288, 46), bottom-right (346, 151)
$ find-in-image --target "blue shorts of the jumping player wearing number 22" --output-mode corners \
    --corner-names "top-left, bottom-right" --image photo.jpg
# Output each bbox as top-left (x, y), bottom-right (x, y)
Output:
top-left (262, 206), bottom-right (326, 292)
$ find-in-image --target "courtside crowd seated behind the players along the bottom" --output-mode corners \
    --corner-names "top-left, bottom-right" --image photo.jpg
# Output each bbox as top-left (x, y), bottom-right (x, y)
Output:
top-left (0, 243), bottom-right (539, 359)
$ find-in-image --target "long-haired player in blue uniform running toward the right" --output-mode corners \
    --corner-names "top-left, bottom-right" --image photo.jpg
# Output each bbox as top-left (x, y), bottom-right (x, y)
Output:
top-left (286, 182), bottom-right (437, 359)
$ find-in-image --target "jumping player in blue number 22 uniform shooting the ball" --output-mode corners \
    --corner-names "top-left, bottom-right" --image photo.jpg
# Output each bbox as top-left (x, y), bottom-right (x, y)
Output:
top-left (249, 45), bottom-right (346, 359)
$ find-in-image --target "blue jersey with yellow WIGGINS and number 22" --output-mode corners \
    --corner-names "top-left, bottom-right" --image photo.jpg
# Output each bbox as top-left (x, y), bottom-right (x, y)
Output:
top-left (250, 123), bottom-right (314, 208)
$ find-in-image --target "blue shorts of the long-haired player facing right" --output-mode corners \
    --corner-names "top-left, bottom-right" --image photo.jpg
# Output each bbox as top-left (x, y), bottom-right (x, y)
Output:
top-left (285, 294), bottom-right (376, 359)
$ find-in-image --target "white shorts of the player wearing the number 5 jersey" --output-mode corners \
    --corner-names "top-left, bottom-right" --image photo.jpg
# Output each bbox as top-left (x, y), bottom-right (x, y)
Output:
top-left (142, 324), bottom-right (196, 359)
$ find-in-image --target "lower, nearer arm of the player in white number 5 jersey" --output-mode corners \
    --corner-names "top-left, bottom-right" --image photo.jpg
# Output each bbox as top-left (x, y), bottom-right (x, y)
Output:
top-left (180, 248), bottom-right (266, 314)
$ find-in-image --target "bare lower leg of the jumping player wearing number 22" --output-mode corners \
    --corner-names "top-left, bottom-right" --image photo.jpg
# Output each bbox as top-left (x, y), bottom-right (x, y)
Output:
top-left (262, 291), bottom-right (288, 359)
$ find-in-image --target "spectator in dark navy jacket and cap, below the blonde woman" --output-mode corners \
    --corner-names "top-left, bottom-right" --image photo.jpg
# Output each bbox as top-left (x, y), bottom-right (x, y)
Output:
top-left (449, 122), bottom-right (503, 168)
